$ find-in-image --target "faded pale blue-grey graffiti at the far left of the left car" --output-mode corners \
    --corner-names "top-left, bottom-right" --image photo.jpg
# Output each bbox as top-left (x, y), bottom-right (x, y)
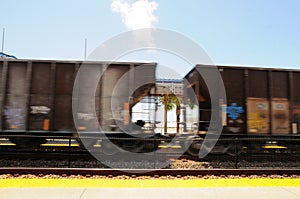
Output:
top-left (4, 106), bottom-right (25, 129)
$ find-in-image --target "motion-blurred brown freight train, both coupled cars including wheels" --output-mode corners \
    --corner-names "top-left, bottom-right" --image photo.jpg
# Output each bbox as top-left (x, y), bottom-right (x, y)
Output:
top-left (0, 60), bottom-right (300, 156)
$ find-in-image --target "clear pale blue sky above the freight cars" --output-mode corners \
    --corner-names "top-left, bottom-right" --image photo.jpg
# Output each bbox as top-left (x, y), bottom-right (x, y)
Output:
top-left (0, 0), bottom-right (300, 72)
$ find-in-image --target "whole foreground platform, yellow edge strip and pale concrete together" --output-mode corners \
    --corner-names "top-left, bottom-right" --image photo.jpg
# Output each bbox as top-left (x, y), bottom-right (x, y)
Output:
top-left (0, 178), bottom-right (300, 199)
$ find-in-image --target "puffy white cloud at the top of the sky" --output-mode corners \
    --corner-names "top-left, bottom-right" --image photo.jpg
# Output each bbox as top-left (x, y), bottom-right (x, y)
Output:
top-left (111, 0), bottom-right (158, 30)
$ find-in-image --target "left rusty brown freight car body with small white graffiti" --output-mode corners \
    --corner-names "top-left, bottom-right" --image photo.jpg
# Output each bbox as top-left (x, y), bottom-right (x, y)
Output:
top-left (0, 60), bottom-right (156, 148)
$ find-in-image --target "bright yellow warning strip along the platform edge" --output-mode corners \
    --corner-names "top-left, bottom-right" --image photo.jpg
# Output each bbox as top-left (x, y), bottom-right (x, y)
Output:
top-left (0, 178), bottom-right (300, 188)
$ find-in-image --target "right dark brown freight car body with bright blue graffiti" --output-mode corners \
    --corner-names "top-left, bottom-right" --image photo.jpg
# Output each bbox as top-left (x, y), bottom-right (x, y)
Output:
top-left (185, 65), bottom-right (300, 155)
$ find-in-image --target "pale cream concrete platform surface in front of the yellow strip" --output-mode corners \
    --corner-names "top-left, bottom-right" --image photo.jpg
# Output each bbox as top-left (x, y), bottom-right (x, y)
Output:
top-left (0, 187), bottom-right (300, 199)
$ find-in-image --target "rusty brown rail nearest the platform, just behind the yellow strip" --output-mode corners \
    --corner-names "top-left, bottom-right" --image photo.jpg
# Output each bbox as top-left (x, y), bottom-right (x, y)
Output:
top-left (0, 168), bottom-right (300, 177)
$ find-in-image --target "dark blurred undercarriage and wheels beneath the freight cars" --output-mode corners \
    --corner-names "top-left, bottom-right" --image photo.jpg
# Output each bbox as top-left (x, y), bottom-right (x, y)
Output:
top-left (0, 132), bottom-right (300, 157)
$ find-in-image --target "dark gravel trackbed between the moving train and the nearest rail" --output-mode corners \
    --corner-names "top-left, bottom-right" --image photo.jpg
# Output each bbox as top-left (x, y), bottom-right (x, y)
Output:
top-left (0, 151), bottom-right (300, 169)
